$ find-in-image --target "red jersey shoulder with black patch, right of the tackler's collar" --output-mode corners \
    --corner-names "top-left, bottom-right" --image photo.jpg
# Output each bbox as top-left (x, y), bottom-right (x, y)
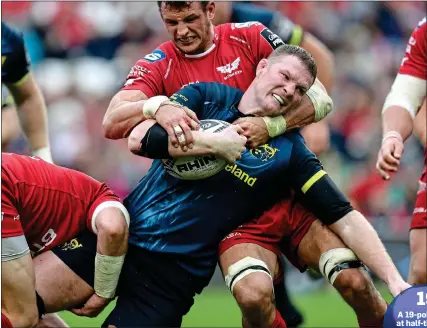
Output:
top-left (231, 22), bottom-right (285, 63)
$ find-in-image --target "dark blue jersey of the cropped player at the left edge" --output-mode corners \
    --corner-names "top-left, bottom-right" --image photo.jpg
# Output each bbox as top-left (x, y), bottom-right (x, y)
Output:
top-left (1, 22), bottom-right (30, 84)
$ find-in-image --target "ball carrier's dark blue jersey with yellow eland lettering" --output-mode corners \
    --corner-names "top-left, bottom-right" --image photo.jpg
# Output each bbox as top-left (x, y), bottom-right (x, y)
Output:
top-left (124, 83), bottom-right (324, 276)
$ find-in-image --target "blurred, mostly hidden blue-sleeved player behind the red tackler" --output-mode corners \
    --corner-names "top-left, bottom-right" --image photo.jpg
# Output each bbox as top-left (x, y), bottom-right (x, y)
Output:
top-left (212, 1), bottom-right (334, 327)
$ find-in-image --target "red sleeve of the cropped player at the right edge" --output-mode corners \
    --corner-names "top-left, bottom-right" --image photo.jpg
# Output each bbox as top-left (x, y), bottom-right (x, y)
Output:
top-left (399, 17), bottom-right (427, 80)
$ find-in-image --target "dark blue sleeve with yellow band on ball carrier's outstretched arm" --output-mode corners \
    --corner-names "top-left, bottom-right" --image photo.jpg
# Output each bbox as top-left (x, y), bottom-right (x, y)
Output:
top-left (289, 133), bottom-right (353, 225)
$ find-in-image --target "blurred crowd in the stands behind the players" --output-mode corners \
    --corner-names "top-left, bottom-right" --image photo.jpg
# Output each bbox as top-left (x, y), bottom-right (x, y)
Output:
top-left (2, 1), bottom-right (425, 243)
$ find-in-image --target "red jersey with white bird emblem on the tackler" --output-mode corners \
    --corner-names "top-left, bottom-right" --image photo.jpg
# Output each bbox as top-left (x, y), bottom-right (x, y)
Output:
top-left (123, 22), bottom-right (284, 98)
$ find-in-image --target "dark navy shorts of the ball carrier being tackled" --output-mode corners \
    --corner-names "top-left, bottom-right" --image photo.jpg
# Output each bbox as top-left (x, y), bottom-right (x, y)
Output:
top-left (53, 232), bottom-right (210, 327)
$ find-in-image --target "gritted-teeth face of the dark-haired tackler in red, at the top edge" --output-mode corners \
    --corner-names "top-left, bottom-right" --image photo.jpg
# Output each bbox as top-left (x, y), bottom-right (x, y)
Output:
top-left (161, 1), bottom-right (215, 55)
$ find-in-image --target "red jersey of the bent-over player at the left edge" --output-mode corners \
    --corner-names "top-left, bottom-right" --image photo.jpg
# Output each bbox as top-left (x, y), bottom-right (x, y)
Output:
top-left (1, 153), bottom-right (120, 252)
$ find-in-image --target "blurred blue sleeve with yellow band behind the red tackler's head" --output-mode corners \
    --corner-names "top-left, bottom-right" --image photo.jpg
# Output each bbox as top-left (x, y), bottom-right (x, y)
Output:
top-left (231, 2), bottom-right (304, 46)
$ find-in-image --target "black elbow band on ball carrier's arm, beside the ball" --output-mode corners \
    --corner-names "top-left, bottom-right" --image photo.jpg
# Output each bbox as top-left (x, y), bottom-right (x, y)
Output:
top-left (138, 123), bottom-right (172, 159)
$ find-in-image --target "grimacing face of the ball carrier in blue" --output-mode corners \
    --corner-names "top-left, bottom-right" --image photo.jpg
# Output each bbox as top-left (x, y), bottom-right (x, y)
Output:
top-left (256, 55), bottom-right (314, 116)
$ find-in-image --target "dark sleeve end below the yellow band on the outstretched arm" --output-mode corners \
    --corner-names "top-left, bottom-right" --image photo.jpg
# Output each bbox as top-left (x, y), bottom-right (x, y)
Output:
top-left (303, 174), bottom-right (353, 225)
